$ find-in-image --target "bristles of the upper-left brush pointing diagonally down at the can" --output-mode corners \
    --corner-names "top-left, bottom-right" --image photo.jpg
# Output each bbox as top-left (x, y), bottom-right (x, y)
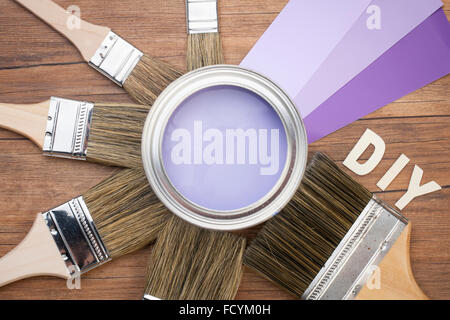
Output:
top-left (123, 55), bottom-right (182, 106)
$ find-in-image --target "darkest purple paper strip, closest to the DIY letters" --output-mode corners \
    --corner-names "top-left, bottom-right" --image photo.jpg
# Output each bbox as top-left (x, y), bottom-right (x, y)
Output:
top-left (304, 9), bottom-right (450, 143)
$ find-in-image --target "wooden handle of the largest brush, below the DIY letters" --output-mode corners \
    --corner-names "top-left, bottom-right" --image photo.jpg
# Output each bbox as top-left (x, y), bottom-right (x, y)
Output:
top-left (357, 224), bottom-right (429, 300)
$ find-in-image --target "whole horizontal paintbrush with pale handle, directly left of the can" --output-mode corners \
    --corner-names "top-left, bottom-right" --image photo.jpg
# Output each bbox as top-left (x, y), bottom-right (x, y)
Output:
top-left (0, 97), bottom-right (150, 168)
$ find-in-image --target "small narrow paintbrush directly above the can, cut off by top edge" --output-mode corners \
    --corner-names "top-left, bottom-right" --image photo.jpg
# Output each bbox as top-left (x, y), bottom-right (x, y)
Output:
top-left (186, 0), bottom-right (224, 71)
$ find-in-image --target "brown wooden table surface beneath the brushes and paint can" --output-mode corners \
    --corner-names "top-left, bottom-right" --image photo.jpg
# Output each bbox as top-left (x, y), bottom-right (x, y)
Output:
top-left (0, 0), bottom-right (450, 299)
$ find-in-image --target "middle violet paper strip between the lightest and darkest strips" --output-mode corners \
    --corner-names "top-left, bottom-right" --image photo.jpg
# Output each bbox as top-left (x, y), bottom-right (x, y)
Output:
top-left (296, 0), bottom-right (442, 117)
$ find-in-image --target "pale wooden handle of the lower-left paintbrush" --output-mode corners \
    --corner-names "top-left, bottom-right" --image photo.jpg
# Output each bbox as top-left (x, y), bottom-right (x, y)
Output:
top-left (0, 214), bottom-right (70, 287)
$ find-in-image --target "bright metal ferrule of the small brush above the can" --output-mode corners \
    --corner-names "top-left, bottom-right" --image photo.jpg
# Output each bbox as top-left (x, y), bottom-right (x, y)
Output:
top-left (186, 0), bottom-right (219, 34)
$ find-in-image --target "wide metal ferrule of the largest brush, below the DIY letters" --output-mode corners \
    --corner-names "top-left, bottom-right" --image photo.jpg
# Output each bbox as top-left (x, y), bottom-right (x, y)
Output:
top-left (302, 196), bottom-right (408, 300)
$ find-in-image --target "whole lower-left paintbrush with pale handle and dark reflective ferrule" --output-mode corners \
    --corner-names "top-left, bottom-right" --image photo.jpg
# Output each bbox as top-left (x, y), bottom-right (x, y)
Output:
top-left (0, 169), bottom-right (170, 286)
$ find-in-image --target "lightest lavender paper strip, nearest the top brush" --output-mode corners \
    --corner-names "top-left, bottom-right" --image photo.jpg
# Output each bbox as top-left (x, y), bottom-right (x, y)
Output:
top-left (241, 0), bottom-right (370, 97)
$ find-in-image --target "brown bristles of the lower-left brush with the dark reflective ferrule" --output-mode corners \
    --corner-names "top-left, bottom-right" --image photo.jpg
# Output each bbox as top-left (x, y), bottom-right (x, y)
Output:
top-left (83, 169), bottom-right (171, 259)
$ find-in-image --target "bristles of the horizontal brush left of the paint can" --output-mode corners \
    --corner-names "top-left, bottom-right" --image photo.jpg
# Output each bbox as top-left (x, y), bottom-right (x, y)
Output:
top-left (87, 103), bottom-right (150, 168)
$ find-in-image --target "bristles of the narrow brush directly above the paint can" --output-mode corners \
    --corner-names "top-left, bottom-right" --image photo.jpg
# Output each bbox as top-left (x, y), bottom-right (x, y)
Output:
top-left (186, 32), bottom-right (224, 71)
